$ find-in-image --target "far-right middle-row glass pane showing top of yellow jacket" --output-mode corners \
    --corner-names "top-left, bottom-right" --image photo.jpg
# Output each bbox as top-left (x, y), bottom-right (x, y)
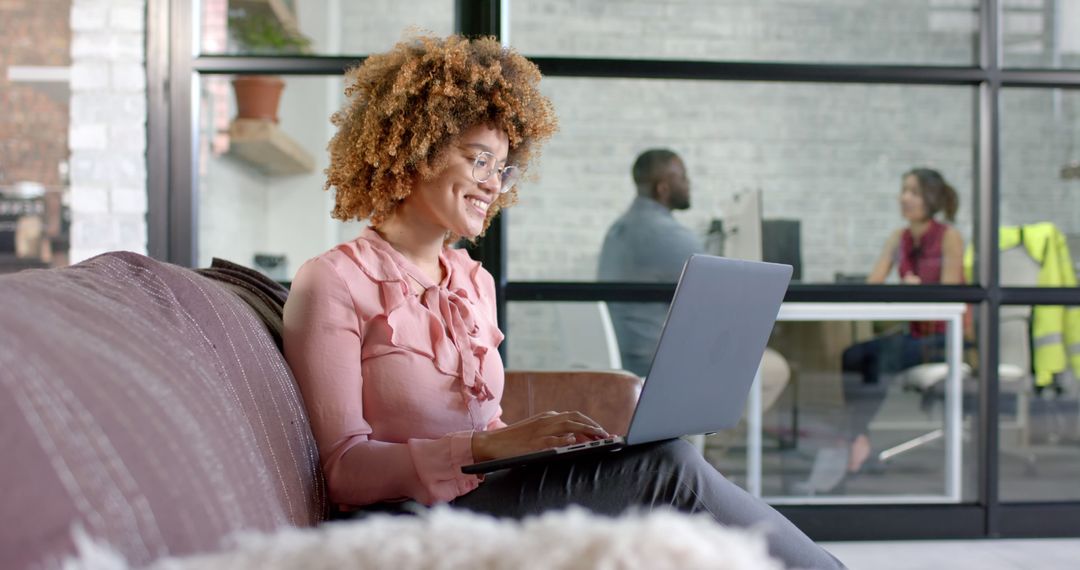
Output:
top-left (1000, 89), bottom-right (1080, 287)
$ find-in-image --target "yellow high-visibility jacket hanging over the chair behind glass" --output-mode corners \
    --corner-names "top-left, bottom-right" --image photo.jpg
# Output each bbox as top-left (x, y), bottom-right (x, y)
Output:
top-left (963, 221), bottom-right (1080, 386)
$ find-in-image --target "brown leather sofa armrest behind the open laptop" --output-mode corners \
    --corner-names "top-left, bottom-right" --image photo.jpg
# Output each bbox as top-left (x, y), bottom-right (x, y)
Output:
top-left (502, 370), bottom-right (642, 435)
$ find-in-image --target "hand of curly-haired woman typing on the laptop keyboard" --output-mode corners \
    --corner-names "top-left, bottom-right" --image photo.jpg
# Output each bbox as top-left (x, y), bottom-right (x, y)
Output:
top-left (472, 411), bottom-right (610, 461)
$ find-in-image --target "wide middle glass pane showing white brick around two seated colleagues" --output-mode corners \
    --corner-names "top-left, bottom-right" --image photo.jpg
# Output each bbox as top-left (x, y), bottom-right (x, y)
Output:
top-left (508, 78), bottom-right (974, 283)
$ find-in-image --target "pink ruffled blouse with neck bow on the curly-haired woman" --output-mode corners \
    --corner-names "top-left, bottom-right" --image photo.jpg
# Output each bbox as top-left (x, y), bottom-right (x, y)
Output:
top-left (284, 229), bottom-right (505, 506)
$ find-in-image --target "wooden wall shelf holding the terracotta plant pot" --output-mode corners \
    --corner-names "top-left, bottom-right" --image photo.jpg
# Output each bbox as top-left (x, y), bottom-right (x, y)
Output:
top-left (229, 119), bottom-right (315, 176)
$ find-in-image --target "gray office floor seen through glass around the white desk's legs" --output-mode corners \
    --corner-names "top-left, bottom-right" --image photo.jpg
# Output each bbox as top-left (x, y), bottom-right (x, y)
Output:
top-left (706, 375), bottom-right (1080, 500)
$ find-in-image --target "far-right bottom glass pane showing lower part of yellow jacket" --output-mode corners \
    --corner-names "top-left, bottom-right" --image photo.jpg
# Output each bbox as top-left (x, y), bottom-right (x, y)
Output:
top-left (998, 306), bottom-right (1080, 501)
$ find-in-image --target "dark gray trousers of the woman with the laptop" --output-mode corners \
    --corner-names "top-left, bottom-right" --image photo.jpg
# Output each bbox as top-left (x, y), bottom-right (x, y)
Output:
top-left (450, 439), bottom-right (843, 569)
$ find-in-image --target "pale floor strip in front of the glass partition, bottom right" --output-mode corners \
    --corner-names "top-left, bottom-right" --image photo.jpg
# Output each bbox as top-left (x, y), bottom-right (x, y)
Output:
top-left (821, 539), bottom-right (1080, 570)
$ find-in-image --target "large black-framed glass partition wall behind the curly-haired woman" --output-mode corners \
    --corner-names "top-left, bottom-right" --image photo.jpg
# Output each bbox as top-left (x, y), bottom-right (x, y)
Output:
top-left (148, 0), bottom-right (1080, 539)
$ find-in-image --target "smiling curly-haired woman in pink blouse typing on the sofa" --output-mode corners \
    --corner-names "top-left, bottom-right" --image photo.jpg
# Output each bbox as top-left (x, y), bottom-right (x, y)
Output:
top-left (284, 37), bottom-right (841, 568)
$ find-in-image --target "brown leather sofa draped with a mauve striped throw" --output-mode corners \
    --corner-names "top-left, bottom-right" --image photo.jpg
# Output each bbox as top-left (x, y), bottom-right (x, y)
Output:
top-left (0, 252), bottom-right (640, 568)
